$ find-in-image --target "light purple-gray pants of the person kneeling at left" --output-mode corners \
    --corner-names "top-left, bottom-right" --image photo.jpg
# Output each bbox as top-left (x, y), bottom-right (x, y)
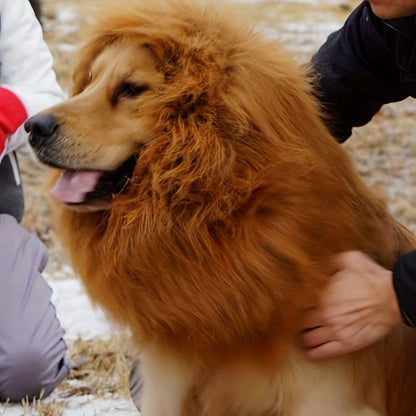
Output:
top-left (0, 180), bottom-right (70, 401)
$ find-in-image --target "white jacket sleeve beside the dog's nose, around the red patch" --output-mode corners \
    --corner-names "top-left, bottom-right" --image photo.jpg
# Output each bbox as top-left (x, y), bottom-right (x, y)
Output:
top-left (0, 0), bottom-right (64, 159)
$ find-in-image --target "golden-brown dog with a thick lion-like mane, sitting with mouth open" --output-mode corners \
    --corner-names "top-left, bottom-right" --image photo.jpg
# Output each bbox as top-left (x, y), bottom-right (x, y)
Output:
top-left (26, 0), bottom-right (416, 416)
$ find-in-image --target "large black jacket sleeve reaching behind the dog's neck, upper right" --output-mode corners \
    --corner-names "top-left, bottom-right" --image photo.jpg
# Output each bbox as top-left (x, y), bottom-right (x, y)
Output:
top-left (311, 1), bottom-right (408, 142)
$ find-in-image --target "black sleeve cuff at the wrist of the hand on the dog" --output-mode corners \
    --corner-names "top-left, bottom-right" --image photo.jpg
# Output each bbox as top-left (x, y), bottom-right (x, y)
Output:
top-left (393, 251), bottom-right (416, 327)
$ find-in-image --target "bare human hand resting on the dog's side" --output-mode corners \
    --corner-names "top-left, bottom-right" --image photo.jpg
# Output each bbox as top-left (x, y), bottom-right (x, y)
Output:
top-left (301, 251), bottom-right (402, 360)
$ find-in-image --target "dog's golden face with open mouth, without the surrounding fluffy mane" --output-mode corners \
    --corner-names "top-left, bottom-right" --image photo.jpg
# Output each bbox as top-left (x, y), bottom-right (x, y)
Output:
top-left (25, 35), bottom-right (163, 210)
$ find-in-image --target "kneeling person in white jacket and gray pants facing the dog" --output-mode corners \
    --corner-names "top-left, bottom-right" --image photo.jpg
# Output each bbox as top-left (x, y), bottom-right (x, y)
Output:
top-left (0, 0), bottom-right (69, 401)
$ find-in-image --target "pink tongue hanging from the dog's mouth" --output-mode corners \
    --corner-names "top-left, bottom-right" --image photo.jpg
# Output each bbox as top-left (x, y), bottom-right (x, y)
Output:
top-left (51, 170), bottom-right (103, 204)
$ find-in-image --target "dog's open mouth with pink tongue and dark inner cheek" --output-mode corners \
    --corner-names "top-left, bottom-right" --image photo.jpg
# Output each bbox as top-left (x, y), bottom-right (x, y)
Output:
top-left (51, 157), bottom-right (136, 209)
